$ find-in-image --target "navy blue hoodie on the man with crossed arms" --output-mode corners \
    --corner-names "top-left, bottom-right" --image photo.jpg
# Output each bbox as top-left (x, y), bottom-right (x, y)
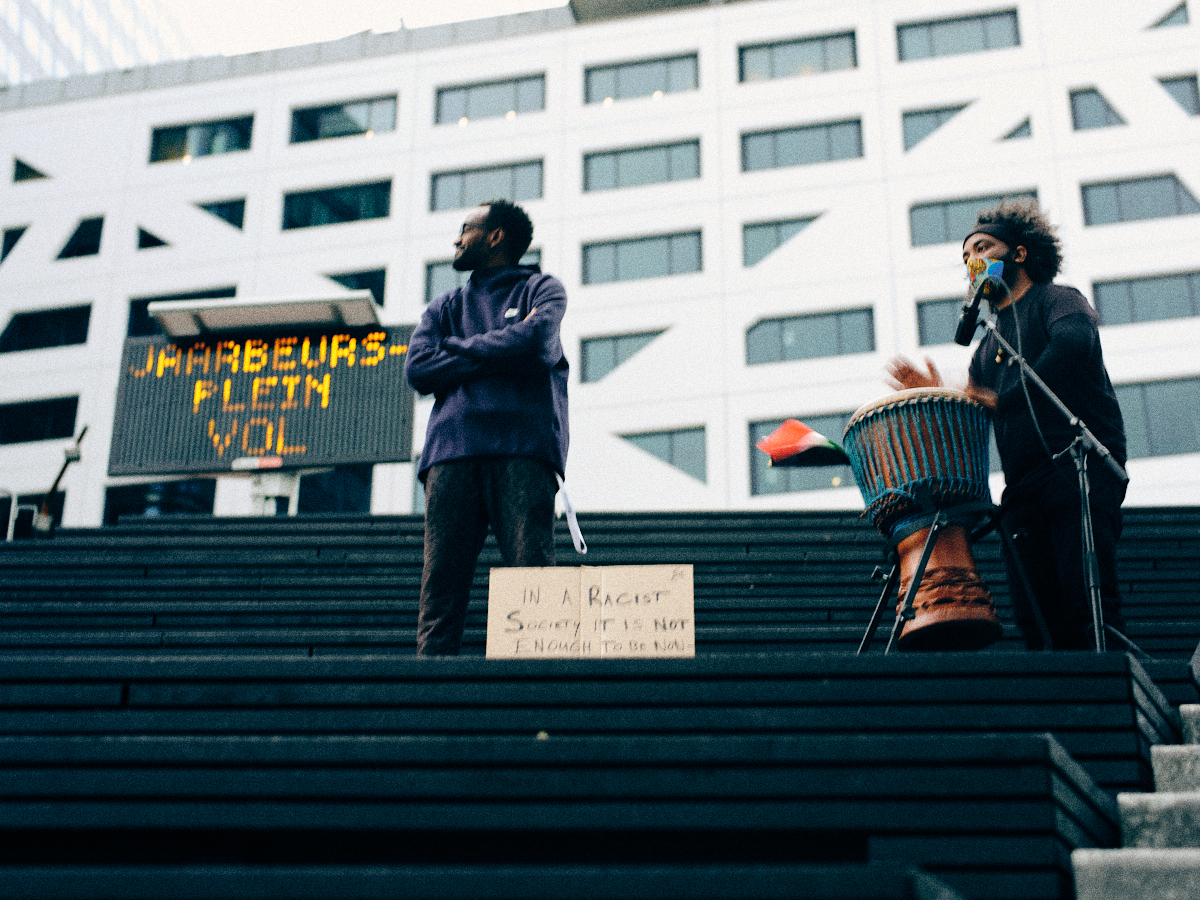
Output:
top-left (404, 265), bottom-right (568, 481)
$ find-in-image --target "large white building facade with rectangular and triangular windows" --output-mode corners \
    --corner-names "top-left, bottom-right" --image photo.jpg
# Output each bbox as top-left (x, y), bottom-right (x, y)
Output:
top-left (0, 0), bottom-right (1200, 524)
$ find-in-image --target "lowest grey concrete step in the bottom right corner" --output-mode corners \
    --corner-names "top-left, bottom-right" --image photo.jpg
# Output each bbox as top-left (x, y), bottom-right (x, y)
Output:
top-left (1070, 848), bottom-right (1200, 900)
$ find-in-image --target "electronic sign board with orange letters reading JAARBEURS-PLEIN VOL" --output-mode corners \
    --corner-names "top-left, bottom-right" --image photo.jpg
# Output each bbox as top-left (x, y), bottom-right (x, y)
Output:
top-left (108, 325), bottom-right (413, 475)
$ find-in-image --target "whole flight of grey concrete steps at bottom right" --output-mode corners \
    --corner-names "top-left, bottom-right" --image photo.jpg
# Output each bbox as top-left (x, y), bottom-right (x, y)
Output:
top-left (1072, 704), bottom-right (1200, 900)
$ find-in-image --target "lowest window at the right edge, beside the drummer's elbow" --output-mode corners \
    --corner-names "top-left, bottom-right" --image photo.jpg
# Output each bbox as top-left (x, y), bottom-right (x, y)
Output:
top-left (1115, 378), bottom-right (1200, 460)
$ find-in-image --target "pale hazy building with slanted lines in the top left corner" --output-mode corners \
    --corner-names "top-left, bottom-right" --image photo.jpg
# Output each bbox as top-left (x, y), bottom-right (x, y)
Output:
top-left (0, 0), bottom-right (188, 85)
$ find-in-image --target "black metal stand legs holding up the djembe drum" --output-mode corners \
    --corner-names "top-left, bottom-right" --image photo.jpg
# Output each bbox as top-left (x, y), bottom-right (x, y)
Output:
top-left (856, 496), bottom-right (1050, 656)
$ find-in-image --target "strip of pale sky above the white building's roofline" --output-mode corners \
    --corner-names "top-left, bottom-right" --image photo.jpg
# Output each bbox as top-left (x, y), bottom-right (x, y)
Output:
top-left (161, 0), bottom-right (565, 56)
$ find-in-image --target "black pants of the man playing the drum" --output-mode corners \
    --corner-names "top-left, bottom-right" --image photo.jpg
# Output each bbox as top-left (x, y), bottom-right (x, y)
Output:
top-left (1003, 456), bottom-right (1126, 650)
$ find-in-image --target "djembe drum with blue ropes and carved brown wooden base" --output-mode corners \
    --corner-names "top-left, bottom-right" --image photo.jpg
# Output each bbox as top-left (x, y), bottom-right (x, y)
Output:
top-left (844, 388), bottom-right (1001, 650)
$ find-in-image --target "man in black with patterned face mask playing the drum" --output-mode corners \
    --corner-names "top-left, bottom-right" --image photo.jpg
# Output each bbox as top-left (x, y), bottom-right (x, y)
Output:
top-left (887, 199), bottom-right (1126, 650)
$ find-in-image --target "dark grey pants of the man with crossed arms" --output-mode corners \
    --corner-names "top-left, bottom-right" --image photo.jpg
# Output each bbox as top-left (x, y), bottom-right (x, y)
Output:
top-left (416, 456), bottom-right (558, 656)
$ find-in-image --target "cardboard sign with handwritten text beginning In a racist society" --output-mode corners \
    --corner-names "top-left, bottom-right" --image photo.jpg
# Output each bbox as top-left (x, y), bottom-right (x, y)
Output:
top-left (487, 565), bottom-right (696, 659)
